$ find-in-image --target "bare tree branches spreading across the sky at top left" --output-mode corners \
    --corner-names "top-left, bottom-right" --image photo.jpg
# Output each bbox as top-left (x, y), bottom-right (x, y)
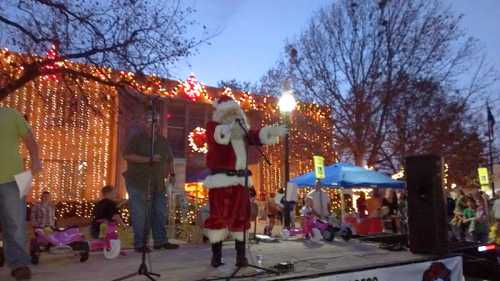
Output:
top-left (0, 0), bottom-right (208, 100)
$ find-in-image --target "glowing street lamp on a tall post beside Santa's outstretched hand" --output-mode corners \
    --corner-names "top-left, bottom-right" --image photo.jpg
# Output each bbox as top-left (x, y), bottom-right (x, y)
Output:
top-left (278, 86), bottom-right (297, 228)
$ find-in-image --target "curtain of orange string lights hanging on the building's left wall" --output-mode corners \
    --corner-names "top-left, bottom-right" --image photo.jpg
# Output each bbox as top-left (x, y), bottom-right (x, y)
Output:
top-left (0, 50), bottom-right (117, 203)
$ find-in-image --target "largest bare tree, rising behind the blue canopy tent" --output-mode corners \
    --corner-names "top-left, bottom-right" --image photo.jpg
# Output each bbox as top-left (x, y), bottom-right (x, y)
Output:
top-left (263, 0), bottom-right (494, 168)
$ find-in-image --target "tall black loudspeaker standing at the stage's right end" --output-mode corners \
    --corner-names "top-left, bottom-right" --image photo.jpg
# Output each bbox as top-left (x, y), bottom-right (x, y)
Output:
top-left (405, 155), bottom-right (448, 255)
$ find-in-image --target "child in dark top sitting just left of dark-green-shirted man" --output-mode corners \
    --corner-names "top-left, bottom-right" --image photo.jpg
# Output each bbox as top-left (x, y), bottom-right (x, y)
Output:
top-left (90, 185), bottom-right (124, 239)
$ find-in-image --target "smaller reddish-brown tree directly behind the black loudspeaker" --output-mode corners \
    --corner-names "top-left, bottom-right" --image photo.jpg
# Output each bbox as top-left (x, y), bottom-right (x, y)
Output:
top-left (378, 77), bottom-right (485, 186)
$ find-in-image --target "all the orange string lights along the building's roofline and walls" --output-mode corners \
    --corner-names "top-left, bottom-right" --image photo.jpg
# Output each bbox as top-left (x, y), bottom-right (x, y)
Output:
top-left (0, 49), bottom-right (337, 223)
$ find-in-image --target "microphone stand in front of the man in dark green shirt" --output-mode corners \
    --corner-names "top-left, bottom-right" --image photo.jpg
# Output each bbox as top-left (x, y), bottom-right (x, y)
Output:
top-left (112, 98), bottom-right (160, 281)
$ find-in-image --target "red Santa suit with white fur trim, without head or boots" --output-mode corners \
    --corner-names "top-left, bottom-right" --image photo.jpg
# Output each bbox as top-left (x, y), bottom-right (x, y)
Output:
top-left (204, 122), bottom-right (277, 243)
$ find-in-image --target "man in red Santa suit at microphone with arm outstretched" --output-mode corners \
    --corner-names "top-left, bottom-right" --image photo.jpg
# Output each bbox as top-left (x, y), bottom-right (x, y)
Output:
top-left (204, 95), bottom-right (287, 267)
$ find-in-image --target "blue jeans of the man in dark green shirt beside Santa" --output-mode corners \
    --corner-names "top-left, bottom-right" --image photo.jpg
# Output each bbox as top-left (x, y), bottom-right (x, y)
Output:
top-left (126, 181), bottom-right (167, 249)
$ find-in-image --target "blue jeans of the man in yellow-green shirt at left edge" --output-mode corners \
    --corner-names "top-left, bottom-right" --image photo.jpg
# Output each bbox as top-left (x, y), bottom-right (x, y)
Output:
top-left (0, 182), bottom-right (30, 268)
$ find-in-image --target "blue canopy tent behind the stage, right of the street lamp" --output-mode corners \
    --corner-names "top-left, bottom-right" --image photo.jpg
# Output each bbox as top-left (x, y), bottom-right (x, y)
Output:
top-left (290, 163), bottom-right (405, 221)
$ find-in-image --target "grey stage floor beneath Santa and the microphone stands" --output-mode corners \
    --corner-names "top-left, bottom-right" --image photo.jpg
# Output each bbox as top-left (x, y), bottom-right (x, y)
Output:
top-left (0, 236), bottom-right (425, 281)
